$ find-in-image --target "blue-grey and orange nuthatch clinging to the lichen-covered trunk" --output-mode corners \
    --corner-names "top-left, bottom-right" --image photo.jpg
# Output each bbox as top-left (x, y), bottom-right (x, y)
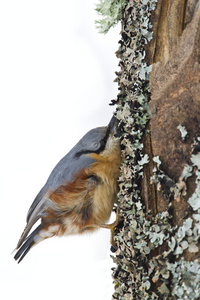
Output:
top-left (14, 116), bottom-right (121, 262)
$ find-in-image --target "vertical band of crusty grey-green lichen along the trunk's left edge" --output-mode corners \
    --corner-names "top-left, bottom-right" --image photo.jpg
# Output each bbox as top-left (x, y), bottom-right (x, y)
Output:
top-left (104, 0), bottom-right (159, 299)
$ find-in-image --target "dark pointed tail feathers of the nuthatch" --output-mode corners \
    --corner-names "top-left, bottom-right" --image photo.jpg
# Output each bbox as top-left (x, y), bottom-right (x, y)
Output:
top-left (14, 224), bottom-right (43, 263)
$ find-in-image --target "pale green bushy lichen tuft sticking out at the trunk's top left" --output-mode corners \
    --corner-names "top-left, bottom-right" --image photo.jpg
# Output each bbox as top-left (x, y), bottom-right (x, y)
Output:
top-left (95, 0), bottom-right (127, 33)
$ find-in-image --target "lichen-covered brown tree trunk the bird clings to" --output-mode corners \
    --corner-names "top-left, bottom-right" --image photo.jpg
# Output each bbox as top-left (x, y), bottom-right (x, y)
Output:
top-left (113, 0), bottom-right (200, 299)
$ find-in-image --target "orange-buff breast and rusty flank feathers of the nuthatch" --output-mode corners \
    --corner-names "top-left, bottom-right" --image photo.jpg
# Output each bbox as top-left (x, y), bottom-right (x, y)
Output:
top-left (43, 144), bottom-right (121, 235)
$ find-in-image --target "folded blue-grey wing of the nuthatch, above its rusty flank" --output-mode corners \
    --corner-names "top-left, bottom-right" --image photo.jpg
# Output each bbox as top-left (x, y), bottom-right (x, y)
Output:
top-left (17, 153), bottom-right (96, 248)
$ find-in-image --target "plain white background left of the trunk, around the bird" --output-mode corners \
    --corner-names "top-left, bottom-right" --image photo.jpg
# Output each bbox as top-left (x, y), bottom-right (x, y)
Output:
top-left (0, 0), bottom-right (120, 300)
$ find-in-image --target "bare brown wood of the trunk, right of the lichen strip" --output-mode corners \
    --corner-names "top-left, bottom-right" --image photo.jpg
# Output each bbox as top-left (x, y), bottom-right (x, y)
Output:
top-left (148, 0), bottom-right (200, 216)
